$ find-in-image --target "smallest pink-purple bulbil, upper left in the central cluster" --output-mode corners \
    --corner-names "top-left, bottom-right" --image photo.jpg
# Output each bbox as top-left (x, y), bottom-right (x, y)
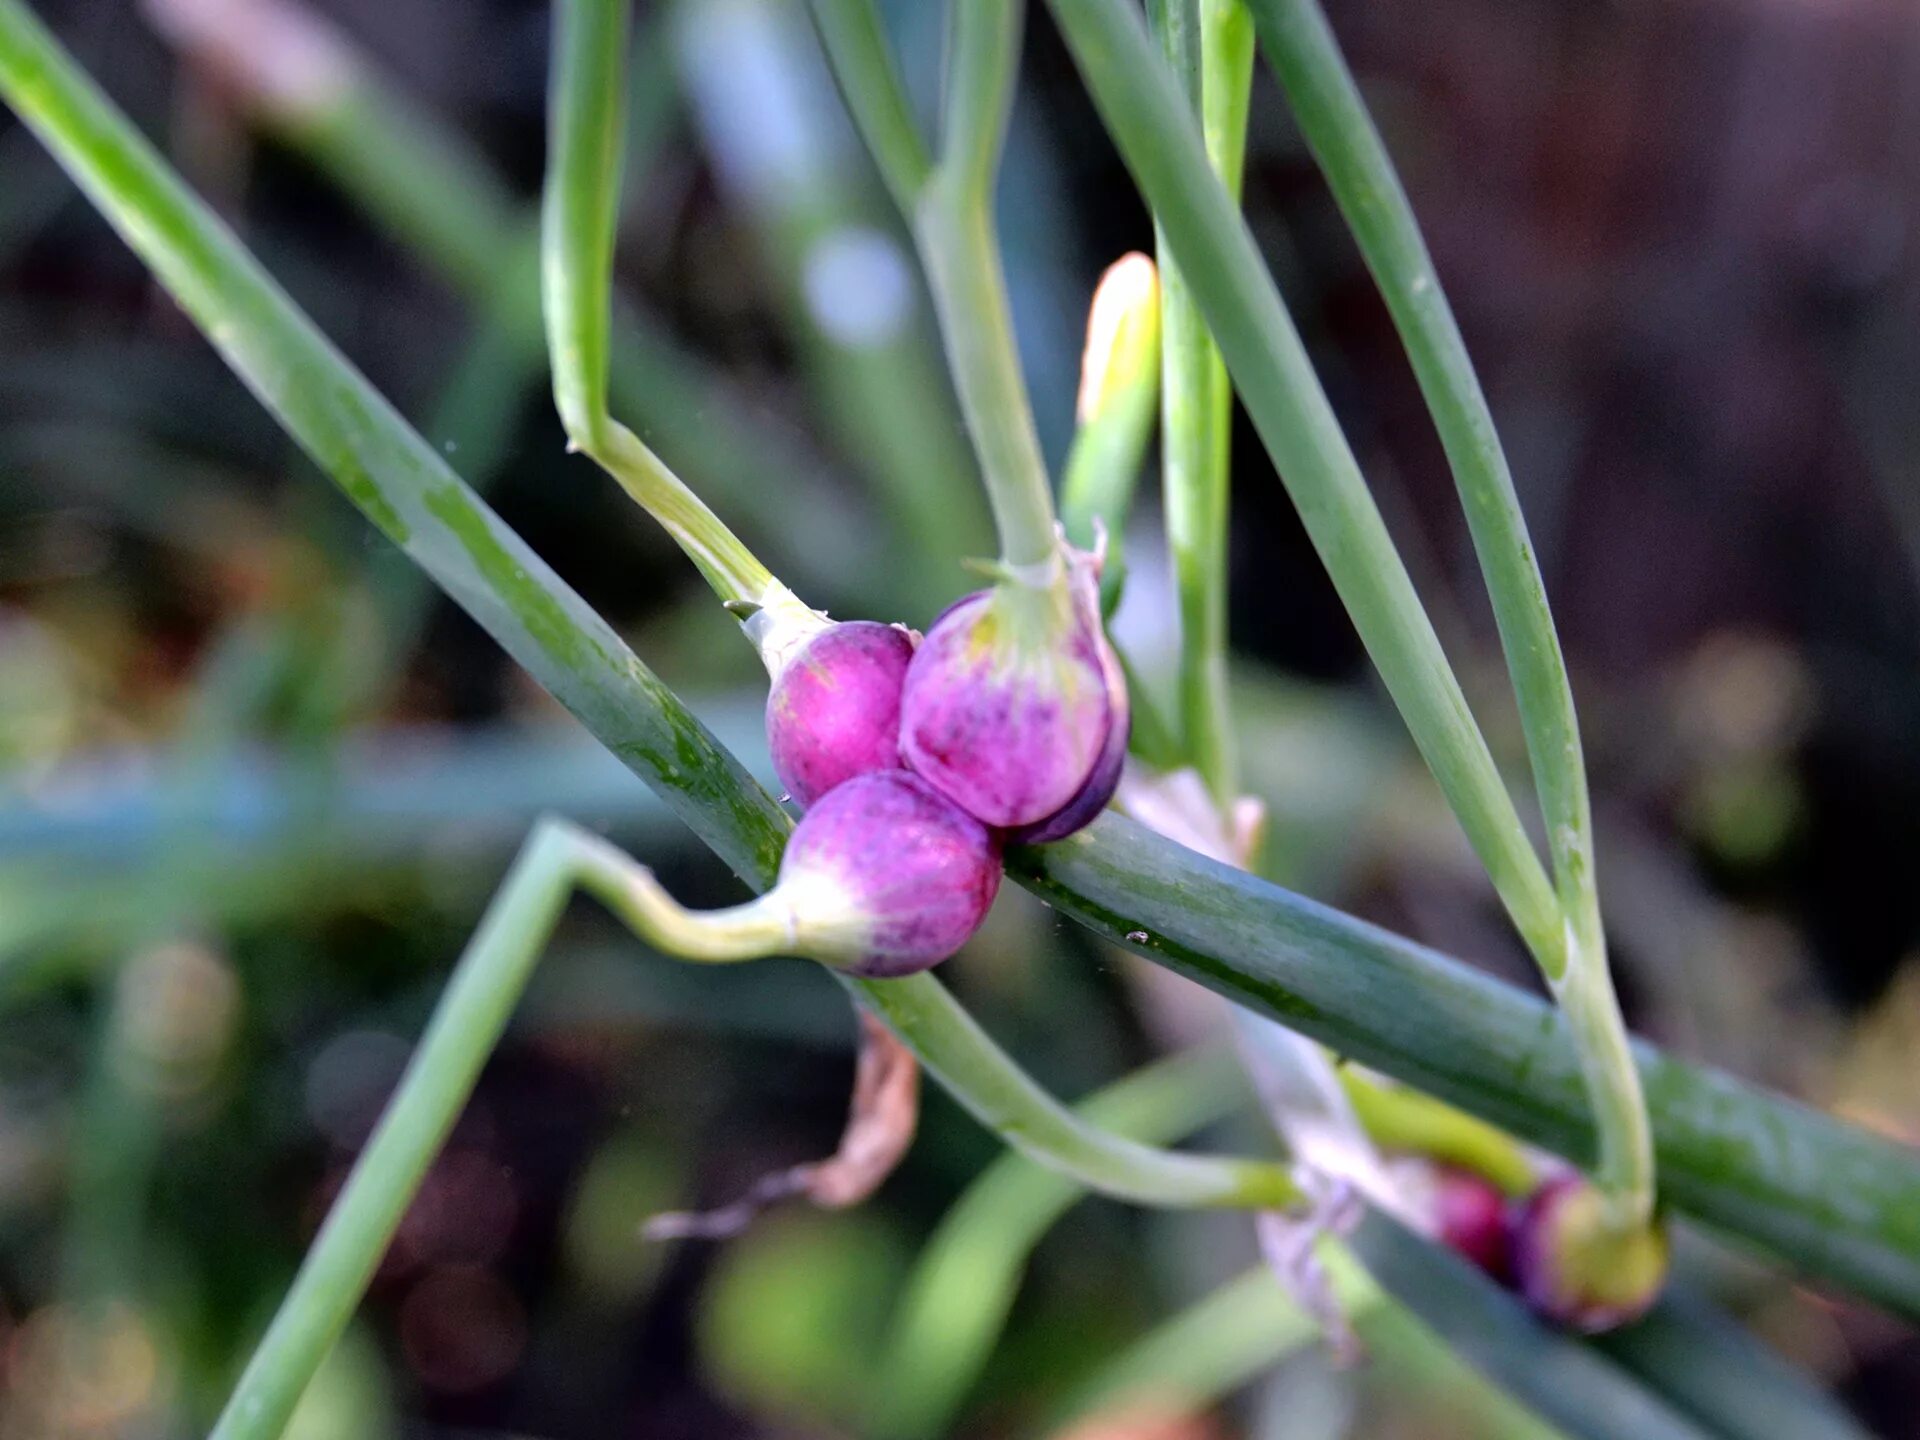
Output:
top-left (766, 620), bottom-right (914, 808)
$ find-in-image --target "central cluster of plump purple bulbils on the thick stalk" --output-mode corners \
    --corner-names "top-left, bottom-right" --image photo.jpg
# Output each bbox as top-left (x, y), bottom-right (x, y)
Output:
top-left (766, 555), bottom-right (1129, 977)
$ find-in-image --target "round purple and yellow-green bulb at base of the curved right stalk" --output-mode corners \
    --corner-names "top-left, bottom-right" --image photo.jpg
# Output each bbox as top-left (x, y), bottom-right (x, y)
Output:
top-left (1513, 1175), bottom-right (1667, 1334)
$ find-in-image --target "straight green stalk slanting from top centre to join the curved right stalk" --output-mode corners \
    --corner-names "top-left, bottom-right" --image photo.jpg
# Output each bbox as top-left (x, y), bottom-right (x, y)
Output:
top-left (1050, 0), bottom-right (1565, 973)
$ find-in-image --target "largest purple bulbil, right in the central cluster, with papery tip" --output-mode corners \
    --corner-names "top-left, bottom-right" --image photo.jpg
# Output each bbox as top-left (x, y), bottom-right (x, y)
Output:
top-left (900, 557), bottom-right (1129, 843)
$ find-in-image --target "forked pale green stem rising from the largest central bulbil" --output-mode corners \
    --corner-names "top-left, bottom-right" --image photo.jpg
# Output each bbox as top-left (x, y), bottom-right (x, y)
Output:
top-left (812, 0), bottom-right (1060, 572)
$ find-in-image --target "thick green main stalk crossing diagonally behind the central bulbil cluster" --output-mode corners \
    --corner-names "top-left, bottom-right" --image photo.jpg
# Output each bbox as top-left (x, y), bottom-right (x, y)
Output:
top-left (15, 0), bottom-right (1920, 1313)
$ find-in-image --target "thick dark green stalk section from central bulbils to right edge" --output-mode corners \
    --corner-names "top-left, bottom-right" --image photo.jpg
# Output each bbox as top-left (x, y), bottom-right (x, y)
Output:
top-left (1008, 814), bottom-right (1920, 1313)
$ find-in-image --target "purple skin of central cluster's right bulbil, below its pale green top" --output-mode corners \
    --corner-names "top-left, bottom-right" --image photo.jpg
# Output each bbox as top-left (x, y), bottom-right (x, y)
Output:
top-left (900, 589), bottom-right (1125, 839)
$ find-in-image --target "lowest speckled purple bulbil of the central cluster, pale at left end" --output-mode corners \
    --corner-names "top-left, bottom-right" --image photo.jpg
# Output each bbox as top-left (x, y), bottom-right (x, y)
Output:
top-left (780, 770), bottom-right (1000, 979)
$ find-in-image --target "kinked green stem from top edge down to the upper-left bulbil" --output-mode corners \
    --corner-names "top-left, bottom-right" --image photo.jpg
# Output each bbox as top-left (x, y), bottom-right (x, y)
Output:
top-left (540, 0), bottom-right (774, 603)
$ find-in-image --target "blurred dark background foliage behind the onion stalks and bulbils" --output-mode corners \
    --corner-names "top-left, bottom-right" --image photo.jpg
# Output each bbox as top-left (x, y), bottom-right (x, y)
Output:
top-left (0, 0), bottom-right (1920, 1440)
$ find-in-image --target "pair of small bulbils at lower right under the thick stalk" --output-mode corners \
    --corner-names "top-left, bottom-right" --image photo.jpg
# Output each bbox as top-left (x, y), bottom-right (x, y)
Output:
top-left (1430, 1165), bottom-right (1667, 1334)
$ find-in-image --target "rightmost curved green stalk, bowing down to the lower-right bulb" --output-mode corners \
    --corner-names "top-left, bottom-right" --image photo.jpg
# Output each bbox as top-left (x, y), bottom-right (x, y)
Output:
top-left (1235, 0), bottom-right (1655, 1225)
